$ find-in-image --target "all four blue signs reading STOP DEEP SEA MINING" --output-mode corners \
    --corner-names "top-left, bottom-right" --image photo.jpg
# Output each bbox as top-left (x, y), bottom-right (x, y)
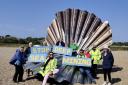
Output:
top-left (28, 46), bottom-right (91, 67)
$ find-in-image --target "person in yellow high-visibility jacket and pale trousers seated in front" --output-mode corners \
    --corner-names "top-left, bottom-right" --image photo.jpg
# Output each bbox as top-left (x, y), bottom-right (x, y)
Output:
top-left (39, 52), bottom-right (59, 85)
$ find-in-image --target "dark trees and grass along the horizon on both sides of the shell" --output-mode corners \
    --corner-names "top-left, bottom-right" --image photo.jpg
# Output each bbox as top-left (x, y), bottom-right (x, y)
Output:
top-left (0, 35), bottom-right (128, 51)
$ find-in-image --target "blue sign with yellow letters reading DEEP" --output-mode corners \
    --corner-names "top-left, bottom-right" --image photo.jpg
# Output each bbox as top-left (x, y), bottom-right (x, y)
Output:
top-left (52, 46), bottom-right (72, 56)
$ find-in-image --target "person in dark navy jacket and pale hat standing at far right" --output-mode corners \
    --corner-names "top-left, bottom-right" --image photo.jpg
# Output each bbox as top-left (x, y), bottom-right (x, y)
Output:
top-left (102, 46), bottom-right (114, 85)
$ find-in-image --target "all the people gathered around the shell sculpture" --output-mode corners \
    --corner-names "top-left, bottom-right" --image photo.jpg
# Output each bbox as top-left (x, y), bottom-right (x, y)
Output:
top-left (10, 40), bottom-right (114, 85)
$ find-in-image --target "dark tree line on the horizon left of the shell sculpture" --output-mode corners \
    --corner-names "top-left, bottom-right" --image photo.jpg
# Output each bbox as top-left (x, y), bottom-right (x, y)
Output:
top-left (0, 35), bottom-right (45, 46)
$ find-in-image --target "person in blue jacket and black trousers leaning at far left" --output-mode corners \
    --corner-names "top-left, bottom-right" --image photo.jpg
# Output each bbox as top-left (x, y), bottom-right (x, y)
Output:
top-left (10, 46), bottom-right (26, 82)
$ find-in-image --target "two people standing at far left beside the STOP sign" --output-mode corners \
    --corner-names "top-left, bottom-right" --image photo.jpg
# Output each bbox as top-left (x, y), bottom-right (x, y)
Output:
top-left (9, 42), bottom-right (32, 83)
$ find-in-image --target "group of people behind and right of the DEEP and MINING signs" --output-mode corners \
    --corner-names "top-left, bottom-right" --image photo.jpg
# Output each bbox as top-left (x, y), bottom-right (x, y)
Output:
top-left (56, 40), bottom-right (114, 85)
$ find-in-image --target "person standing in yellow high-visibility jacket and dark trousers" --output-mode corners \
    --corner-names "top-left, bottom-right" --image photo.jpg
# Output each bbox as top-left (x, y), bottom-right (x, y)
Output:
top-left (90, 47), bottom-right (101, 78)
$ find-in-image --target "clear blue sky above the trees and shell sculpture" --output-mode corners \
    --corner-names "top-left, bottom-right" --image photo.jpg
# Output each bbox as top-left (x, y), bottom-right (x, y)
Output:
top-left (0, 0), bottom-right (128, 42)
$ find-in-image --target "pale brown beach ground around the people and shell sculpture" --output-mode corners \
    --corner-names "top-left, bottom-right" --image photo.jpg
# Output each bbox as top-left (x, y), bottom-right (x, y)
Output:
top-left (0, 47), bottom-right (128, 85)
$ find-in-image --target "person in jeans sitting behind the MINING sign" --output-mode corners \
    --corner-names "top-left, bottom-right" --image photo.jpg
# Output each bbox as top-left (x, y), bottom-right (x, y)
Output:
top-left (77, 49), bottom-right (96, 84)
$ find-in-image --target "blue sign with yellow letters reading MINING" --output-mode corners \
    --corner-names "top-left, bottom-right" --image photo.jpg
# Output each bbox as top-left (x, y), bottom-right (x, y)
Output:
top-left (62, 56), bottom-right (92, 67)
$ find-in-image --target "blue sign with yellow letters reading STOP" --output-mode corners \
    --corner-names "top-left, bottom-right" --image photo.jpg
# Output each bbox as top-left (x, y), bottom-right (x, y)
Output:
top-left (31, 46), bottom-right (51, 54)
